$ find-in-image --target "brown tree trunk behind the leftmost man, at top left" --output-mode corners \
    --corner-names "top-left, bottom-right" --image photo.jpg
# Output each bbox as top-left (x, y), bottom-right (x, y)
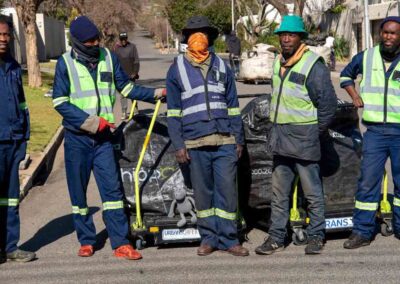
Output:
top-left (11, 0), bottom-right (44, 88)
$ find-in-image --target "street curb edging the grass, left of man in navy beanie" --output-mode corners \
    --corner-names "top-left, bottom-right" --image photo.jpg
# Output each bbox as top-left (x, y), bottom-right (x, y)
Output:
top-left (20, 126), bottom-right (64, 201)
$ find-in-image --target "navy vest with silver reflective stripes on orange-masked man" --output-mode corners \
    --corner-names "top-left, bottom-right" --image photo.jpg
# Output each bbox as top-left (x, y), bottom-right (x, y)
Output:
top-left (177, 55), bottom-right (228, 125)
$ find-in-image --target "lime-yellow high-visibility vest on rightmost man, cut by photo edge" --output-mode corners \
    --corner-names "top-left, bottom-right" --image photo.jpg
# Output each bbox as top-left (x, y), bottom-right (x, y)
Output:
top-left (360, 46), bottom-right (400, 123)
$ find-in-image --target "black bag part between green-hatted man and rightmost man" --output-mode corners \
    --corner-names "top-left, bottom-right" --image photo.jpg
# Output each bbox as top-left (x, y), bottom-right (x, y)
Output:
top-left (320, 101), bottom-right (362, 215)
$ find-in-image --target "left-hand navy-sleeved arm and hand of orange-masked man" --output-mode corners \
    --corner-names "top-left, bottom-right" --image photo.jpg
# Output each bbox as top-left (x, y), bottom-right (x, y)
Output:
top-left (167, 63), bottom-right (190, 163)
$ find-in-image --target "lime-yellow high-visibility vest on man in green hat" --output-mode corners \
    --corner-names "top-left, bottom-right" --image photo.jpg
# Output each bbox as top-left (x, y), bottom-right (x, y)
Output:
top-left (270, 51), bottom-right (321, 124)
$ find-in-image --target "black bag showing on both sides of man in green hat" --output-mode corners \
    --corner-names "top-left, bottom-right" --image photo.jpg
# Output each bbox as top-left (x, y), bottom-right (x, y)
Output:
top-left (239, 95), bottom-right (362, 228)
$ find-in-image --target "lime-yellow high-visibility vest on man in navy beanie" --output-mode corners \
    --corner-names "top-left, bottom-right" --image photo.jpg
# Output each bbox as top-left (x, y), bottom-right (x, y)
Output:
top-left (63, 48), bottom-right (116, 123)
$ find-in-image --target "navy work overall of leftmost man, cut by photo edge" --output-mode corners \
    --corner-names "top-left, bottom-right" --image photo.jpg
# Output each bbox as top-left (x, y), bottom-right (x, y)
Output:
top-left (0, 55), bottom-right (29, 253)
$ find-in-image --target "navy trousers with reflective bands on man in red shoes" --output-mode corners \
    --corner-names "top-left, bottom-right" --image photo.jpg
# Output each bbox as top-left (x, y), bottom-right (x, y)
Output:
top-left (64, 130), bottom-right (129, 249)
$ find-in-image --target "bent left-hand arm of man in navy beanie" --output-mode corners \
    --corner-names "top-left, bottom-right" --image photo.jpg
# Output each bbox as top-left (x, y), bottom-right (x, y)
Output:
top-left (53, 57), bottom-right (100, 134)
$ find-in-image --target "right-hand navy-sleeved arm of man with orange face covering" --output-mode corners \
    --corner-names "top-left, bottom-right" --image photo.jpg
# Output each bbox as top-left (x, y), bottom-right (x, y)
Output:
top-left (225, 62), bottom-right (244, 158)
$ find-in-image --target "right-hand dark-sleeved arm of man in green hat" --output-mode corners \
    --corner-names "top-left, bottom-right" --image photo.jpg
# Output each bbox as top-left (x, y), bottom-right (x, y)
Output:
top-left (306, 61), bottom-right (337, 135)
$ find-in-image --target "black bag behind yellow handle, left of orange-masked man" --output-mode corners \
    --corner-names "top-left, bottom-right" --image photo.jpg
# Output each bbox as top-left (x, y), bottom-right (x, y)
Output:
top-left (114, 113), bottom-right (193, 216)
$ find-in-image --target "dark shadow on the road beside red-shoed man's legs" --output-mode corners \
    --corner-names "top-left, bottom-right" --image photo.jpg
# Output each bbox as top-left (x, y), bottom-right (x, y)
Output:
top-left (20, 207), bottom-right (101, 252)
